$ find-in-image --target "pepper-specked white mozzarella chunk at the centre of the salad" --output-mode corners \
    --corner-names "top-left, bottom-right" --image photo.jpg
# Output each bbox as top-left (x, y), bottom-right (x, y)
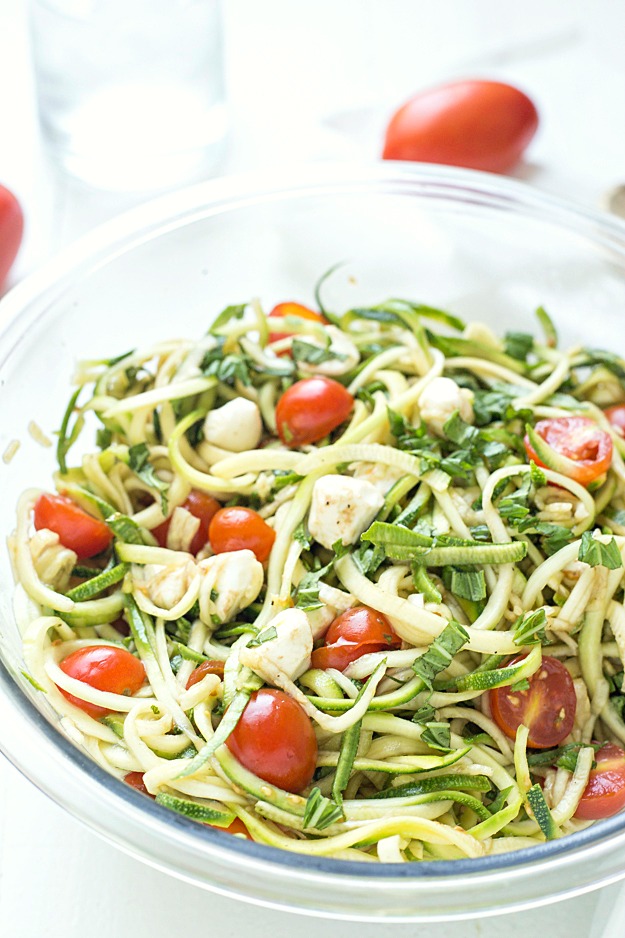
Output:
top-left (308, 475), bottom-right (384, 548)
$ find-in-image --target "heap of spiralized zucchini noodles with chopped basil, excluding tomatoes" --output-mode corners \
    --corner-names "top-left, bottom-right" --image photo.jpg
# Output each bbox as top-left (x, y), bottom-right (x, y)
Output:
top-left (10, 288), bottom-right (625, 862)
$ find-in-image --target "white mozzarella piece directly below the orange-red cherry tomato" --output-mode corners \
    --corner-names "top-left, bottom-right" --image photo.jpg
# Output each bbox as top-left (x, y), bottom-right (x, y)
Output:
top-left (198, 550), bottom-right (264, 625)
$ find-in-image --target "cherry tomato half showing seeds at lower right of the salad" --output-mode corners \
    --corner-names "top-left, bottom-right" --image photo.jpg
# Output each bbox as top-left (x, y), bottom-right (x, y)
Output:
top-left (489, 655), bottom-right (577, 749)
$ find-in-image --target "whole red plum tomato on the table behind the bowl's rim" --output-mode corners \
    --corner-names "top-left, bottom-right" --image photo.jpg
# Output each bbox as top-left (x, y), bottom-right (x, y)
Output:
top-left (382, 81), bottom-right (538, 173)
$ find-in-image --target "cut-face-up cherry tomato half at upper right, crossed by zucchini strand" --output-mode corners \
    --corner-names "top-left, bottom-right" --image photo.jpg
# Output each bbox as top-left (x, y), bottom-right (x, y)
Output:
top-left (524, 417), bottom-right (613, 485)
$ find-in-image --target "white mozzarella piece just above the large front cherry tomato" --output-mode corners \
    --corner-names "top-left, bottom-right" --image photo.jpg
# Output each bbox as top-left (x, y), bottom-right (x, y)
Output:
top-left (239, 609), bottom-right (313, 684)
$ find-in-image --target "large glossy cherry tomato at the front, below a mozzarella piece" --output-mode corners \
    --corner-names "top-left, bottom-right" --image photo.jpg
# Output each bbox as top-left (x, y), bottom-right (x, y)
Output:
top-left (226, 687), bottom-right (317, 792)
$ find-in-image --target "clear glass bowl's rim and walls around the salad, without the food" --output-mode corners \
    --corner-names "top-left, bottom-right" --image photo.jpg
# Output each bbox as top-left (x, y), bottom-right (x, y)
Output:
top-left (0, 163), bottom-right (625, 921)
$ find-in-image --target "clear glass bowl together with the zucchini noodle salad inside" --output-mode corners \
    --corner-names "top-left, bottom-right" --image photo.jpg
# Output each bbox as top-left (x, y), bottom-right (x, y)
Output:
top-left (0, 163), bottom-right (625, 921)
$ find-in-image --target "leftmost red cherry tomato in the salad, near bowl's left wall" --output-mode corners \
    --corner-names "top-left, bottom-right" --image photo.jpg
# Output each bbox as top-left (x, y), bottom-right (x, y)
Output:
top-left (34, 492), bottom-right (113, 560)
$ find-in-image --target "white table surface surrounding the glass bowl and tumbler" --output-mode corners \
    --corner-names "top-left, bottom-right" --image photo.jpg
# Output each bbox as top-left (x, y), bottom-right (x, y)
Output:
top-left (0, 0), bottom-right (625, 938)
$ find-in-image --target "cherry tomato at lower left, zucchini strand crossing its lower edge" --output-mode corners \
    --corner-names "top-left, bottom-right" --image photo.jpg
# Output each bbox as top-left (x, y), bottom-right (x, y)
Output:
top-left (59, 645), bottom-right (145, 720)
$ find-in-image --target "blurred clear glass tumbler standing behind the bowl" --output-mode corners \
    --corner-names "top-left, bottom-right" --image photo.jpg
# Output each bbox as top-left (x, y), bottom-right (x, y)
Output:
top-left (30, 0), bottom-right (227, 192)
